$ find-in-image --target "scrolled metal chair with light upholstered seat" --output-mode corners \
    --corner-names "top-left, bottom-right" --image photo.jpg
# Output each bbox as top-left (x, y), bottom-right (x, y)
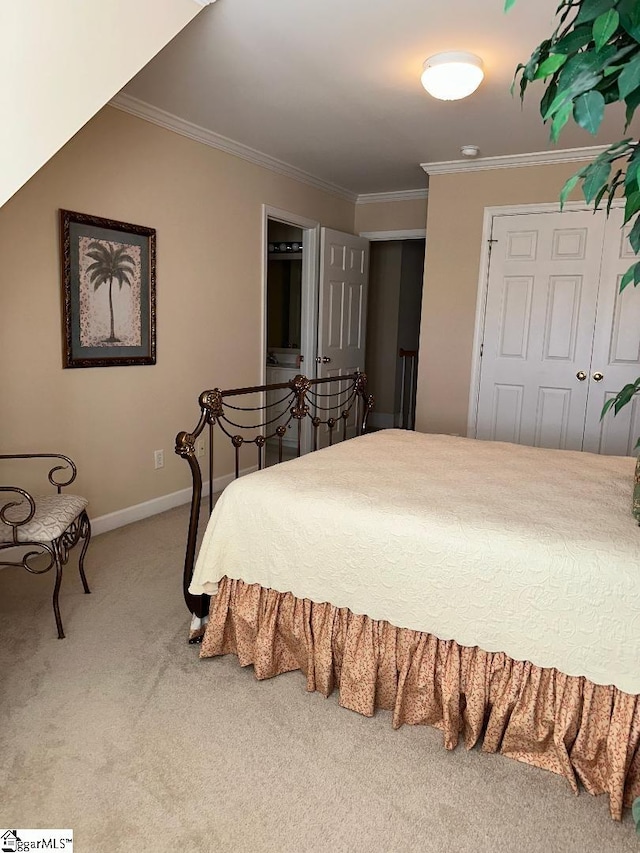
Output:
top-left (0, 453), bottom-right (91, 639)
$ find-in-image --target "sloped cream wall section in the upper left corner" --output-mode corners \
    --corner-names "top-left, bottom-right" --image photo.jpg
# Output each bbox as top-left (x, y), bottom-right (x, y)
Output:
top-left (0, 0), bottom-right (202, 204)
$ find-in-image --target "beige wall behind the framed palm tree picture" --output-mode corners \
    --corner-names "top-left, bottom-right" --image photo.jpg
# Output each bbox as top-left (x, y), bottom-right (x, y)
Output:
top-left (0, 107), bottom-right (354, 517)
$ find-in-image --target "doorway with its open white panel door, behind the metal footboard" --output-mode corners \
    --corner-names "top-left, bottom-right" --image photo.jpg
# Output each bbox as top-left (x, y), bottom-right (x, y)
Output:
top-left (262, 205), bottom-right (369, 453)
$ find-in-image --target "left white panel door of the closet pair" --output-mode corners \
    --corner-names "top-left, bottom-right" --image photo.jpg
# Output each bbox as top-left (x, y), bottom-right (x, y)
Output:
top-left (476, 211), bottom-right (605, 450)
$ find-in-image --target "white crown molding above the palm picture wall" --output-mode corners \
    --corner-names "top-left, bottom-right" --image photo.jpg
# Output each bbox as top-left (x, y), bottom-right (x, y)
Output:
top-left (109, 92), bottom-right (358, 203)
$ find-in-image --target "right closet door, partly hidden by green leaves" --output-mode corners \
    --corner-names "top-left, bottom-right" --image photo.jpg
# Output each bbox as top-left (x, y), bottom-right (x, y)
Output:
top-left (584, 208), bottom-right (640, 456)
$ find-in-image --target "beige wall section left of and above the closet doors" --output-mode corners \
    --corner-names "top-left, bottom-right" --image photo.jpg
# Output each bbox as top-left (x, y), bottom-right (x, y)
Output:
top-left (416, 163), bottom-right (580, 435)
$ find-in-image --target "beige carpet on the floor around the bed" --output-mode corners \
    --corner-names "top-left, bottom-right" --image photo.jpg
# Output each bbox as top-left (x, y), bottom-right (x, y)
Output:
top-left (0, 508), bottom-right (640, 853)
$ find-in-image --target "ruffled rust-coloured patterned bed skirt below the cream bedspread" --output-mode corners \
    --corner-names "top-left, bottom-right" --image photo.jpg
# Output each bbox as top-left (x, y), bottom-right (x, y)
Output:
top-left (200, 577), bottom-right (640, 820)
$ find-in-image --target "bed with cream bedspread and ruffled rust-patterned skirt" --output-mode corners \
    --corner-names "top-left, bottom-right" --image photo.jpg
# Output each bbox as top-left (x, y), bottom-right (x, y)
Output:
top-left (175, 372), bottom-right (640, 819)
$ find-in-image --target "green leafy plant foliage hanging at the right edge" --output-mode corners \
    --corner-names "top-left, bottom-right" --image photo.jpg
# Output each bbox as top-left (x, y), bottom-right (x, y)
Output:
top-left (505, 0), bottom-right (640, 424)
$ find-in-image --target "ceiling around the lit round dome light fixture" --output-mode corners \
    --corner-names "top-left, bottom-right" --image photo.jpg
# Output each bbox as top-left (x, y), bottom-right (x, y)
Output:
top-left (119, 0), bottom-right (623, 194)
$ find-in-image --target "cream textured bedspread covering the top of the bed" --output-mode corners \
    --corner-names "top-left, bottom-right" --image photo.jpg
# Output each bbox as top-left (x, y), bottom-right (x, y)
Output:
top-left (190, 430), bottom-right (640, 694)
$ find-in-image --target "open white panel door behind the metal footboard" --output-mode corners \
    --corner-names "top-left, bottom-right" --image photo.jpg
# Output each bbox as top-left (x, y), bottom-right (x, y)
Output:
top-left (316, 228), bottom-right (369, 430)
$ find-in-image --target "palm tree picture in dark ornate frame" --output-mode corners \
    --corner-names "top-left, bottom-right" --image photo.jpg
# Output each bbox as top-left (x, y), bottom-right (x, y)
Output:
top-left (60, 210), bottom-right (156, 367)
